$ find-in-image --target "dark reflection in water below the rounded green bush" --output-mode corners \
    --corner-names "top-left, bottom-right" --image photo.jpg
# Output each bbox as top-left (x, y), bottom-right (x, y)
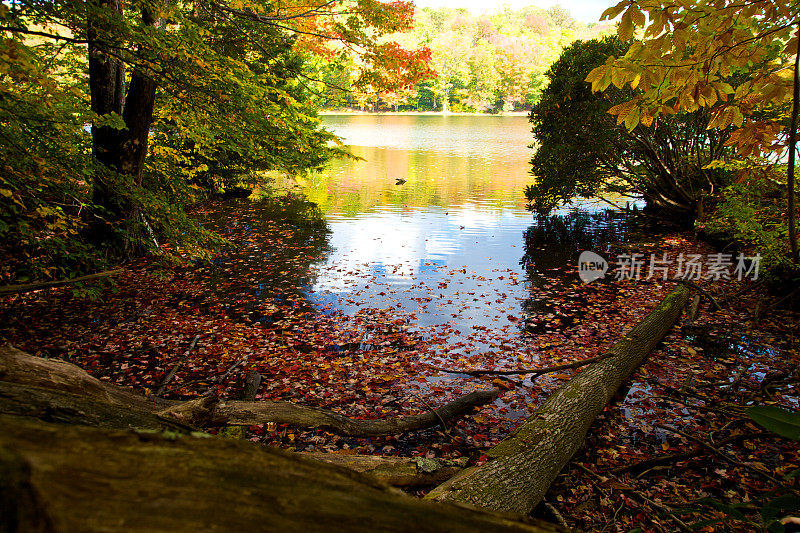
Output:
top-left (520, 210), bottom-right (628, 314)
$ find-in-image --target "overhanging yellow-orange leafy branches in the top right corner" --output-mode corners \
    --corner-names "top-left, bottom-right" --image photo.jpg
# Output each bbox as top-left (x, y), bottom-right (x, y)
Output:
top-left (587, 0), bottom-right (800, 263)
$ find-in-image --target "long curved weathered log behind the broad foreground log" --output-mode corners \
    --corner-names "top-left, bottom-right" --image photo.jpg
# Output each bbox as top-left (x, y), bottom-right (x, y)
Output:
top-left (0, 346), bottom-right (499, 437)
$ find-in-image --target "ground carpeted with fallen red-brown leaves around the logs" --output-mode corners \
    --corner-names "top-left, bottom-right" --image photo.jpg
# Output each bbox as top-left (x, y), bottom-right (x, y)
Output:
top-left (0, 196), bottom-right (800, 531)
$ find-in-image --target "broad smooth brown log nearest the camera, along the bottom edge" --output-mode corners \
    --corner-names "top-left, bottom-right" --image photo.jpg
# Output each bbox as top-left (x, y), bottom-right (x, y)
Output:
top-left (0, 415), bottom-right (557, 533)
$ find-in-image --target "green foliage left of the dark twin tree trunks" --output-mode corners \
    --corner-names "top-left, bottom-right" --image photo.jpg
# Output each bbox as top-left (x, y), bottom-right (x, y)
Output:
top-left (0, 26), bottom-right (102, 283)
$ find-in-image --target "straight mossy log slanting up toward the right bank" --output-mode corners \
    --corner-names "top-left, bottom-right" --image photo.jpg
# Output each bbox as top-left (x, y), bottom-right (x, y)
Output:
top-left (427, 285), bottom-right (689, 514)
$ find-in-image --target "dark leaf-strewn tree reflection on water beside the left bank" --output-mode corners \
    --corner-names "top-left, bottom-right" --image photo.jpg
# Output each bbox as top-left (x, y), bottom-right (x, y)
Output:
top-left (201, 197), bottom-right (331, 318)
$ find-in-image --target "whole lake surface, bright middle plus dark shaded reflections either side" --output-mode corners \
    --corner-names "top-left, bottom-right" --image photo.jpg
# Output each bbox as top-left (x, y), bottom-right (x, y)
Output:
top-left (204, 115), bottom-right (624, 365)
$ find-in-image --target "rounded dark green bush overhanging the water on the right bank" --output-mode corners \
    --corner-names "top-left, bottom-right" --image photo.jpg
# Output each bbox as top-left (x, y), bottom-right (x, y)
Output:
top-left (525, 37), bottom-right (728, 219)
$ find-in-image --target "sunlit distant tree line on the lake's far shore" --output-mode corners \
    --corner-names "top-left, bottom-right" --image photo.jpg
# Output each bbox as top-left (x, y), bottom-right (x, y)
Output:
top-left (315, 6), bottom-right (613, 113)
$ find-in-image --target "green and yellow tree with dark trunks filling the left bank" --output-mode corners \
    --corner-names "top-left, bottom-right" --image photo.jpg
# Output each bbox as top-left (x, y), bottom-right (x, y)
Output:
top-left (0, 0), bottom-right (412, 283)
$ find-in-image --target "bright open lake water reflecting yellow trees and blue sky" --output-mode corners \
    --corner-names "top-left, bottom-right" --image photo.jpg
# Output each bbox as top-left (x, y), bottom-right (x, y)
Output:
top-left (278, 115), bottom-right (620, 356)
